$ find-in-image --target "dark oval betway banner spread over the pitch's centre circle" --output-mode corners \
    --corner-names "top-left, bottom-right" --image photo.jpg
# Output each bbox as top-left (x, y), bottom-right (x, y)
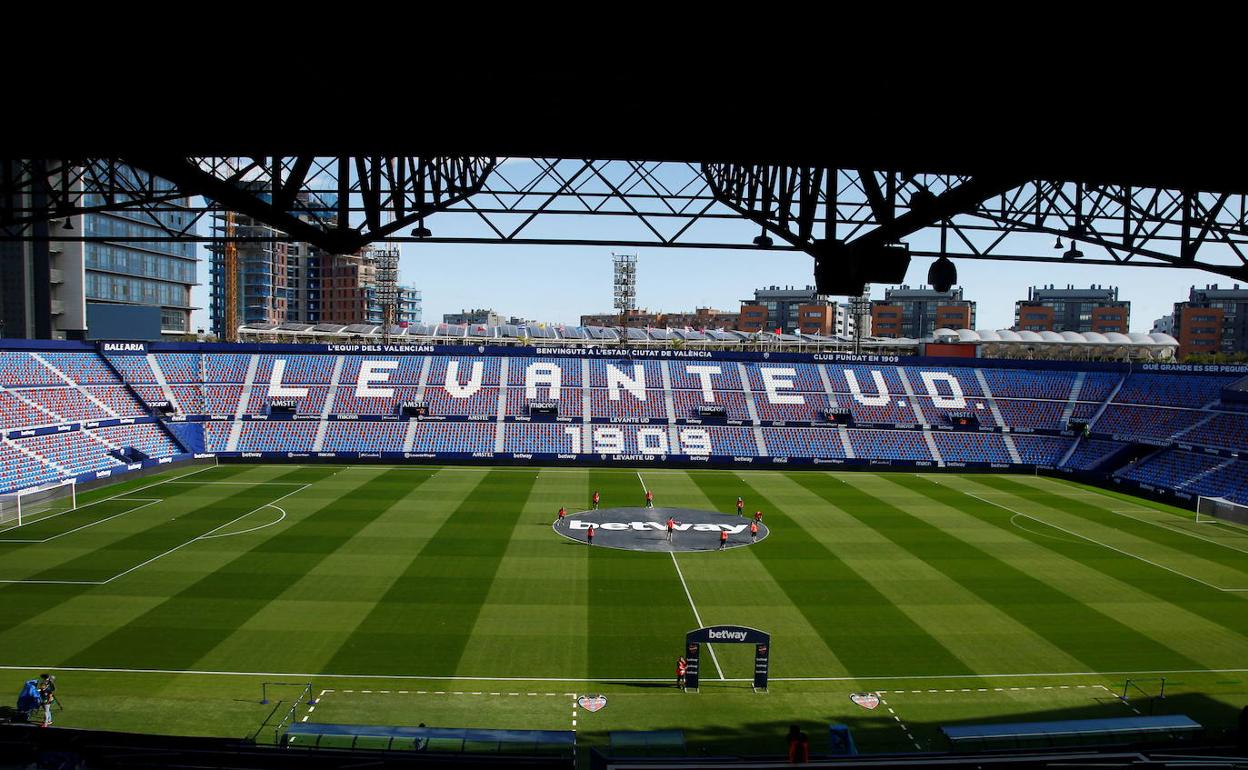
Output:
top-left (553, 508), bottom-right (768, 552)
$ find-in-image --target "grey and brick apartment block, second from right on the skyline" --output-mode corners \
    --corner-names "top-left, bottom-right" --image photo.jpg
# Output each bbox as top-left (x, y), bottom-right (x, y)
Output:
top-left (1013, 285), bottom-right (1131, 334)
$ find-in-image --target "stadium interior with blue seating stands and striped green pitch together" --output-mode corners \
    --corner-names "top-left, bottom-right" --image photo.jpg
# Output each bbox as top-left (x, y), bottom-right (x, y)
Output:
top-left (0, 341), bottom-right (1248, 756)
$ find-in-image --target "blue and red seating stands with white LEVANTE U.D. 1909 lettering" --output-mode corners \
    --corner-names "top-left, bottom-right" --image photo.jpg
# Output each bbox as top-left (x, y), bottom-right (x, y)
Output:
top-left (0, 341), bottom-right (1248, 504)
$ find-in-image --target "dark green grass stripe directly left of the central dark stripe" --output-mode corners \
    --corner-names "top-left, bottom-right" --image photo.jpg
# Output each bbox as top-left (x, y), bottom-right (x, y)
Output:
top-left (326, 470), bottom-right (535, 675)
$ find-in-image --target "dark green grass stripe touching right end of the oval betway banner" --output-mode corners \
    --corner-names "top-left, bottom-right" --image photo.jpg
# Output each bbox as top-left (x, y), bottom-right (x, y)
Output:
top-left (691, 474), bottom-right (973, 674)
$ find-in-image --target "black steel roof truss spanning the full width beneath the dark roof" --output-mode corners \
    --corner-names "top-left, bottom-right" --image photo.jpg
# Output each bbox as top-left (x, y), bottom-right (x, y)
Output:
top-left (0, 155), bottom-right (1248, 290)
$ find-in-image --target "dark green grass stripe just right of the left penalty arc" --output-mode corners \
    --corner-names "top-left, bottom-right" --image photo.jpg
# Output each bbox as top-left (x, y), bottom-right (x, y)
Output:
top-left (67, 464), bottom-right (428, 669)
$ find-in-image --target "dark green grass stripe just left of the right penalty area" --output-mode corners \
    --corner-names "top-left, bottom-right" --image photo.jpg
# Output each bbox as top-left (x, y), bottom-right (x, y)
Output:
top-left (888, 474), bottom-right (1218, 671)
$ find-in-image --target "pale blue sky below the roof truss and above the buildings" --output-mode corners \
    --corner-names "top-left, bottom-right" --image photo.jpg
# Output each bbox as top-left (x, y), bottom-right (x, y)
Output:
top-left (184, 194), bottom-right (1231, 332)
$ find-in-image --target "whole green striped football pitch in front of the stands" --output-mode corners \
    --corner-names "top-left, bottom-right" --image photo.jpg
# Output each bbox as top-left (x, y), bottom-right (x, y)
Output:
top-left (0, 464), bottom-right (1248, 754)
